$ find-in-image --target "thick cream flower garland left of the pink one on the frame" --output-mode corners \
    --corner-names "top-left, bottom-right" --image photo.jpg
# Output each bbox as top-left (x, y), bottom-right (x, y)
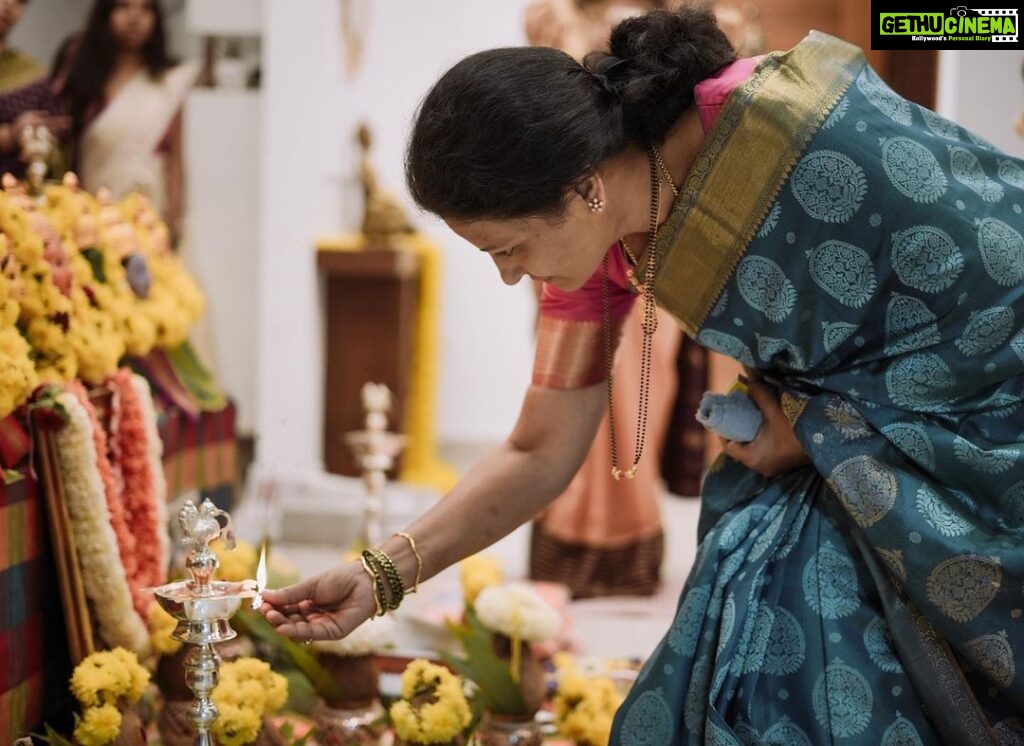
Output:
top-left (49, 383), bottom-right (150, 657)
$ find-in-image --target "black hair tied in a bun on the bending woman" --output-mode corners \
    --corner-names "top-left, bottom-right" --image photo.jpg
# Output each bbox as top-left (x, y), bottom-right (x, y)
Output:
top-left (406, 6), bottom-right (736, 220)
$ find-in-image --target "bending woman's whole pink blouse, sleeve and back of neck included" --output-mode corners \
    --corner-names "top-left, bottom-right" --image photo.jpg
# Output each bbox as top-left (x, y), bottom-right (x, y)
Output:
top-left (534, 57), bottom-right (762, 389)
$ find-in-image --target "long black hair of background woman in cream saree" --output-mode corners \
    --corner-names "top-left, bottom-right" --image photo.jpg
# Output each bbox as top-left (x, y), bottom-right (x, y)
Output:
top-left (65, 0), bottom-right (176, 135)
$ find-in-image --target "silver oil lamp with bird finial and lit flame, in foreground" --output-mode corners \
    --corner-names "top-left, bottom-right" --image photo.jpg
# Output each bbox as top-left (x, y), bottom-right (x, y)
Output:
top-left (153, 499), bottom-right (262, 746)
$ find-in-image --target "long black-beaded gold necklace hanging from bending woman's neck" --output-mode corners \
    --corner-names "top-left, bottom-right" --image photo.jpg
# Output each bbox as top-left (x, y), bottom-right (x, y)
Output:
top-left (601, 145), bottom-right (678, 480)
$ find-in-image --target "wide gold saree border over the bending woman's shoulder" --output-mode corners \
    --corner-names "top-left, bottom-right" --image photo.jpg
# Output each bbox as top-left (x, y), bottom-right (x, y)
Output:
top-left (648, 32), bottom-right (865, 337)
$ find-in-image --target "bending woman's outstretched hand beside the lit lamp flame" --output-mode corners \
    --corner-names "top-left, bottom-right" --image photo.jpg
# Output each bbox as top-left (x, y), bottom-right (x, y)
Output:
top-left (260, 562), bottom-right (377, 642)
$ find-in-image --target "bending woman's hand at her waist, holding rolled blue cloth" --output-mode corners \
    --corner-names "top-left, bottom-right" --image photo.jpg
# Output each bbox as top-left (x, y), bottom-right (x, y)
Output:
top-left (722, 380), bottom-right (811, 477)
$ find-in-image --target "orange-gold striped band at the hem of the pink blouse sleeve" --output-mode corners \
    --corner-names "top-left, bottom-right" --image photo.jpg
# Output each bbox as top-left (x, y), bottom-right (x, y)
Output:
top-left (532, 314), bottom-right (625, 389)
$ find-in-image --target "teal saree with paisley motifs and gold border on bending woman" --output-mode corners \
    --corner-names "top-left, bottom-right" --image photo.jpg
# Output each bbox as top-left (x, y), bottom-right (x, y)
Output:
top-left (612, 34), bottom-right (1024, 746)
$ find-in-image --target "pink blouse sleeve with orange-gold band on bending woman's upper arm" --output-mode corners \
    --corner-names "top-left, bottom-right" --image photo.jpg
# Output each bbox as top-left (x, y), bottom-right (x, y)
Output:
top-left (534, 244), bottom-right (637, 389)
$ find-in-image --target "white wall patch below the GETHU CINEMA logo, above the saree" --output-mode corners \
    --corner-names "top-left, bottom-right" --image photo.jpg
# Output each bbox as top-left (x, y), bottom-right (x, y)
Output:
top-left (936, 49), bottom-right (1024, 158)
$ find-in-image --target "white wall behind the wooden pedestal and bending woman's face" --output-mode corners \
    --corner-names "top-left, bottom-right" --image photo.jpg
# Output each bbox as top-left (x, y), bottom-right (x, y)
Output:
top-left (257, 0), bottom-right (534, 470)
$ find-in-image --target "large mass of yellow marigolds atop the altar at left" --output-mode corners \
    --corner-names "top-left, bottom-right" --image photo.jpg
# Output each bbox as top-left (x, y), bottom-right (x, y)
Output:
top-left (0, 176), bottom-right (206, 418)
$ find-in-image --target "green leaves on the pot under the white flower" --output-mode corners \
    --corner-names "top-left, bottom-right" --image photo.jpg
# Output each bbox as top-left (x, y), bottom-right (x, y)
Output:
top-left (442, 609), bottom-right (528, 715)
